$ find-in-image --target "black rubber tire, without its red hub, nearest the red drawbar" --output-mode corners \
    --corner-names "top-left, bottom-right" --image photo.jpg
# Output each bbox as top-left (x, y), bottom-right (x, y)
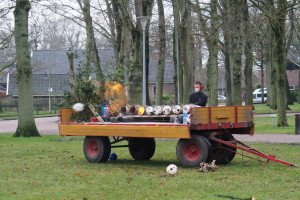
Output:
top-left (176, 135), bottom-right (209, 168)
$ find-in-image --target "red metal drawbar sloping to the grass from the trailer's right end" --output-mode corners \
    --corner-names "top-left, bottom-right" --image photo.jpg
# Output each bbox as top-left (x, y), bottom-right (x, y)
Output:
top-left (210, 134), bottom-right (299, 167)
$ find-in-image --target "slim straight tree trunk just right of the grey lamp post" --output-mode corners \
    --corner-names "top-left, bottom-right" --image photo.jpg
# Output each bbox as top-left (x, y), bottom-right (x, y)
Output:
top-left (155, 0), bottom-right (166, 105)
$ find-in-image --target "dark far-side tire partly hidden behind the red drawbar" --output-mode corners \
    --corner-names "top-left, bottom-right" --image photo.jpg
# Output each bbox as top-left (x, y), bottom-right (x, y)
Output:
top-left (207, 134), bottom-right (236, 165)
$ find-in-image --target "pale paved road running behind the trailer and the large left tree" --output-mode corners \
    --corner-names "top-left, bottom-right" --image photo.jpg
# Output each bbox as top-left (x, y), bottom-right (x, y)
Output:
top-left (0, 117), bottom-right (300, 145)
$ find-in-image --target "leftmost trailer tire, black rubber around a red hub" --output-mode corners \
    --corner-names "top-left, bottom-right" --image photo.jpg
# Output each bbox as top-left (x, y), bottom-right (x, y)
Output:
top-left (83, 136), bottom-right (111, 163)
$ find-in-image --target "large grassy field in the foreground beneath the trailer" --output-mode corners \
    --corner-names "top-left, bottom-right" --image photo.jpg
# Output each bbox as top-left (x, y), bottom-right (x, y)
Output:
top-left (0, 134), bottom-right (300, 200)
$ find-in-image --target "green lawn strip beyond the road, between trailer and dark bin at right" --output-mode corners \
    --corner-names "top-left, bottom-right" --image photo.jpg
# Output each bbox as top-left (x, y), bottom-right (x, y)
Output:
top-left (254, 116), bottom-right (295, 134)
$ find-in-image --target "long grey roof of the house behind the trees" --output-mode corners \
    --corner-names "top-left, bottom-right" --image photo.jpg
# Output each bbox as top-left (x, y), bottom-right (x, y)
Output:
top-left (9, 49), bottom-right (174, 95)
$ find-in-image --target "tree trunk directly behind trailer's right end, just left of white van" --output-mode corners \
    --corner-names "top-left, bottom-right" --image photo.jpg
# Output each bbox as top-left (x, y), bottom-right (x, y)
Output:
top-left (242, 0), bottom-right (253, 105)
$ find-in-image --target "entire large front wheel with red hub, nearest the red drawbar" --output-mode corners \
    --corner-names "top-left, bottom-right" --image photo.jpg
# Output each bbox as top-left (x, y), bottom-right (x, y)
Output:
top-left (176, 135), bottom-right (209, 168)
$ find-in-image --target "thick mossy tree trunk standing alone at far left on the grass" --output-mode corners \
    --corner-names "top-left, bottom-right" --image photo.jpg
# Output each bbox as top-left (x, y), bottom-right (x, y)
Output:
top-left (14, 0), bottom-right (40, 137)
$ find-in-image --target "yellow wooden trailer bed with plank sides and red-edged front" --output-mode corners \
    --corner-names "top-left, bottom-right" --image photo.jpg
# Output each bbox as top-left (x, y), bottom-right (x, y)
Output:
top-left (59, 106), bottom-right (254, 139)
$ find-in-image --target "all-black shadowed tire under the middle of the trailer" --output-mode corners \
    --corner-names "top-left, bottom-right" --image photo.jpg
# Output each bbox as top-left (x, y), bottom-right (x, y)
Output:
top-left (128, 138), bottom-right (156, 160)
